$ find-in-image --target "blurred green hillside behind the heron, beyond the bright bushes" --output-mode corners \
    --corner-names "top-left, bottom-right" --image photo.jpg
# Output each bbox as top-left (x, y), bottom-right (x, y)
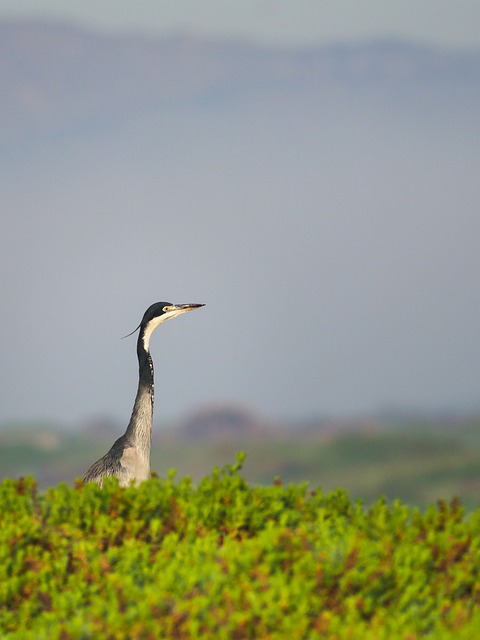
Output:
top-left (0, 417), bottom-right (480, 509)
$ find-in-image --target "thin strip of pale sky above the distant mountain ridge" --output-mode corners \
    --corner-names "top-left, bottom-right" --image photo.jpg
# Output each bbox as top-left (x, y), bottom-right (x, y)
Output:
top-left (0, 0), bottom-right (480, 47)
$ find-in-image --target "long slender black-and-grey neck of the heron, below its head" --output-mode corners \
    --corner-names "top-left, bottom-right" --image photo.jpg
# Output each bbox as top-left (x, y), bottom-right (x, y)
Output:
top-left (125, 330), bottom-right (153, 452)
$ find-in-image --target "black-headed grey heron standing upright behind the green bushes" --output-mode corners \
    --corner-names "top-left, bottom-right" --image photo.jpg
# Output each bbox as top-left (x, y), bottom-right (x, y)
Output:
top-left (82, 302), bottom-right (205, 487)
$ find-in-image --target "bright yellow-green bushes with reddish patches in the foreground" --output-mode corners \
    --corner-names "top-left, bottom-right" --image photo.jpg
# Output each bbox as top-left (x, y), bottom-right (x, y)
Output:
top-left (0, 454), bottom-right (480, 640)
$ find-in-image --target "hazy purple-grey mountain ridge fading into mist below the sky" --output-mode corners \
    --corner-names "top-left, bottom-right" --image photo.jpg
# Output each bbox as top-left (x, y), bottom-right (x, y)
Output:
top-left (0, 20), bottom-right (480, 144)
